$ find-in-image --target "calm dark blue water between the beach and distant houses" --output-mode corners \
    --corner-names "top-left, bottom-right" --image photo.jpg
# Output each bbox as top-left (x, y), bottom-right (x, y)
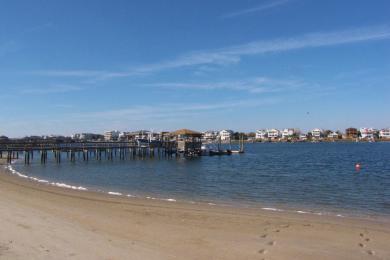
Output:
top-left (10, 143), bottom-right (390, 216)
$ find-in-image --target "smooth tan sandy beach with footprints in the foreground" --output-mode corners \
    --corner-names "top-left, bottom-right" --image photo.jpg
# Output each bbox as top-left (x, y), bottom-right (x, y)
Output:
top-left (0, 166), bottom-right (390, 260)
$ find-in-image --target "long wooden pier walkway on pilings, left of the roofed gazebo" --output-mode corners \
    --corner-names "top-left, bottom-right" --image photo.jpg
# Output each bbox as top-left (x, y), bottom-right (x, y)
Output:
top-left (0, 141), bottom-right (180, 164)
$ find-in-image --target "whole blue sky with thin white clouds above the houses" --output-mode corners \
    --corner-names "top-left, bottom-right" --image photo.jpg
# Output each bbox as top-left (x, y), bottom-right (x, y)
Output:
top-left (0, 0), bottom-right (390, 137)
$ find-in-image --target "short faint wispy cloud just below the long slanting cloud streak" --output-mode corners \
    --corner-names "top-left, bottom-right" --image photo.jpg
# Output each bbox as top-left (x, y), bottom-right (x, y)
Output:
top-left (143, 77), bottom-right (307, 94)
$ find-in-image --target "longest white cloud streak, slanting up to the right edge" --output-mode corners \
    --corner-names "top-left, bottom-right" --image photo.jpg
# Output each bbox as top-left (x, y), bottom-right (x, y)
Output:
top-left (34, 25), bottom-right (390, 80)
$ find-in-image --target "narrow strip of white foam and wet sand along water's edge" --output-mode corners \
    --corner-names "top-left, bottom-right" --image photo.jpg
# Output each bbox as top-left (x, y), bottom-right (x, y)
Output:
top-left (5, 161), bottom-right (390, 222)
